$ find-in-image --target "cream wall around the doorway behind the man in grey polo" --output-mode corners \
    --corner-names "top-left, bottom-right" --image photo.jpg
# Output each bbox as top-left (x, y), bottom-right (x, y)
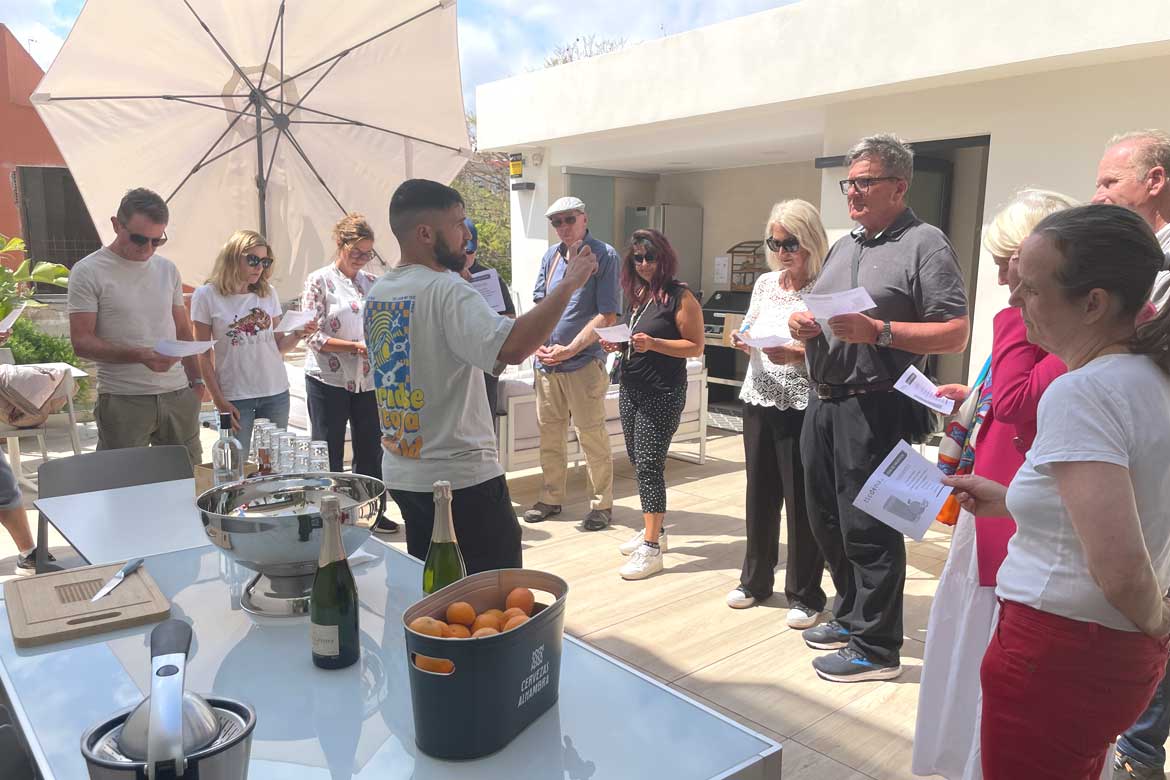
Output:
top-left (821, 57), bottom-right (1170, 383)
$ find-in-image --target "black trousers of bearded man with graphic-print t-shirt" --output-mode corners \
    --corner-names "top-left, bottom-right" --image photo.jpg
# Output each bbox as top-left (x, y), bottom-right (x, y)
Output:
top-left (390, 475), bottom-right (524, 574)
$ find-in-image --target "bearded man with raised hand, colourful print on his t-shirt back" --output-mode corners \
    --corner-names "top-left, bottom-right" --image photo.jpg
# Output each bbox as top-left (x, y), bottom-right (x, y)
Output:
top-left (365, 179), bottom-right (597, 574)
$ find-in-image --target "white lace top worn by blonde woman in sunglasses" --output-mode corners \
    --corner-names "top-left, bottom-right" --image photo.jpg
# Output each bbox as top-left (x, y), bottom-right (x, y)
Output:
top-left (739, 271), bottom-right (812, 409)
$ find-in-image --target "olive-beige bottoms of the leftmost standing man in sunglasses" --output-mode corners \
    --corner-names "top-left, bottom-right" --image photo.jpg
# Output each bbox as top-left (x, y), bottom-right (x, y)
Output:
top-left (94, 387), bottom-right (202, 465)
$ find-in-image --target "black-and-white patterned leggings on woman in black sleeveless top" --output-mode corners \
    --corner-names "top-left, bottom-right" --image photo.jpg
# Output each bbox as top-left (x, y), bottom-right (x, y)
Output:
top-left (618, 382), bottom-right (687, 515)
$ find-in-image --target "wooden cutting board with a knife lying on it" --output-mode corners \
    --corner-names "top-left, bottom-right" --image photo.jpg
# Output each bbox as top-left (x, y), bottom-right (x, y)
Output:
top-left (4, 564), bottom-right (171, 647)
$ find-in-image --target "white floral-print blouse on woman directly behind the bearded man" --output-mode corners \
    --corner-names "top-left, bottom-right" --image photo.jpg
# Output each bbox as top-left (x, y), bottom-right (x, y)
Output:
top-left (301, 263), bottom-right (374, 393)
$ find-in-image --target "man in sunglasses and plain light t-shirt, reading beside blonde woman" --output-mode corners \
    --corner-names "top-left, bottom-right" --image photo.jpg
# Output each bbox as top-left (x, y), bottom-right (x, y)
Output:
top-left (68, 188), bottom-right (204, 464)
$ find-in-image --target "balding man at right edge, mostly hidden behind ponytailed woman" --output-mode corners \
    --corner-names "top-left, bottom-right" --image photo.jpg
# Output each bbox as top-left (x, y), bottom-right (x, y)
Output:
top-left (1093, 130), bottom-right (1170, 780)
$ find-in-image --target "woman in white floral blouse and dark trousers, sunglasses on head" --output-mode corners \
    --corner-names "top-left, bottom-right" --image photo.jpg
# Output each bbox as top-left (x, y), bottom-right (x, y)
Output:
top-left (301, 214), bottom-right (398, 533)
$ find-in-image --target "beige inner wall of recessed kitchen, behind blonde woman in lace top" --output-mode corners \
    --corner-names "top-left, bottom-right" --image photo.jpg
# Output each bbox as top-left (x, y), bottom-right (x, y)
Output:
top-left (655, 160), bottom-right (820, 295)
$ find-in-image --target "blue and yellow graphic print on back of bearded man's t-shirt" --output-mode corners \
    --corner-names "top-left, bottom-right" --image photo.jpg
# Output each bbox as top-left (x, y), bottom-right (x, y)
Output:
top-left (365, 296), bottom-right (426, 458)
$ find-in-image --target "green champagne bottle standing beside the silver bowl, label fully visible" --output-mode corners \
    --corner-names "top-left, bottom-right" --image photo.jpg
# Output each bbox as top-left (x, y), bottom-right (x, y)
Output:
top-left (309, 496), bottom-right (360, 669)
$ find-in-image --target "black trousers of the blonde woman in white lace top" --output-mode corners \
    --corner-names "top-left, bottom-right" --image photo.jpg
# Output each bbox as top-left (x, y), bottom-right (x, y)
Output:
top-left (739, 403), bottom-right (826, 612)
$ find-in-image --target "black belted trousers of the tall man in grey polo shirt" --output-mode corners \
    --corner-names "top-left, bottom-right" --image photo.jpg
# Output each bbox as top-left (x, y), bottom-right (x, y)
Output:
top-left (800, 392), bottom-right (915, 663)
